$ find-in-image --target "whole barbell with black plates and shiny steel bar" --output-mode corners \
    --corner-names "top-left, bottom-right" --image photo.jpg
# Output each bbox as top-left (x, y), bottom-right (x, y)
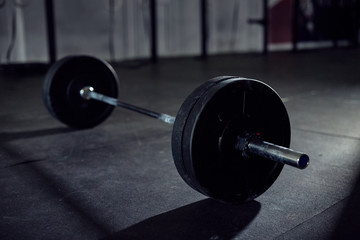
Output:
top-left (43, 56), bottom-right (309, 203)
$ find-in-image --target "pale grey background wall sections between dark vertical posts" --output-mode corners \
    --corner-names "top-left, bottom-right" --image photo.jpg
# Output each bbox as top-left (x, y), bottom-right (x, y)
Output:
top-left (0, 0), bottom-right (262, 63)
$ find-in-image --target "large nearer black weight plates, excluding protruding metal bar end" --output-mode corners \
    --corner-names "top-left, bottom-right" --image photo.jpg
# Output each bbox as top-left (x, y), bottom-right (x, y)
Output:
top-left (172, 77), bottom-right (290, 203)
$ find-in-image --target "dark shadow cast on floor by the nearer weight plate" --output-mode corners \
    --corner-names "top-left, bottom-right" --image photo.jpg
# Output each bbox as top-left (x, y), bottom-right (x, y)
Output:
top-left (103, 199), bottom-right (261, 240)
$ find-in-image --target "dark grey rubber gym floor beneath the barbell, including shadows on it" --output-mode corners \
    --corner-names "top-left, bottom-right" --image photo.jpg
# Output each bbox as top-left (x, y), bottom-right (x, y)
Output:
top-left (0, 49), bottom-right (360, 239)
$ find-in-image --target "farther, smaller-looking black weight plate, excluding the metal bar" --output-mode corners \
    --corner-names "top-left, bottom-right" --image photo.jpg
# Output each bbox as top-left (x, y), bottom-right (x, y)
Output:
top-left (43, 56), bottom-right (118, 129)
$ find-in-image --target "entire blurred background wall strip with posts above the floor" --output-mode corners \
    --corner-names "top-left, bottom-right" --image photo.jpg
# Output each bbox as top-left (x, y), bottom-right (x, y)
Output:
top-left (0, 0), bottom-right (359, 64)
